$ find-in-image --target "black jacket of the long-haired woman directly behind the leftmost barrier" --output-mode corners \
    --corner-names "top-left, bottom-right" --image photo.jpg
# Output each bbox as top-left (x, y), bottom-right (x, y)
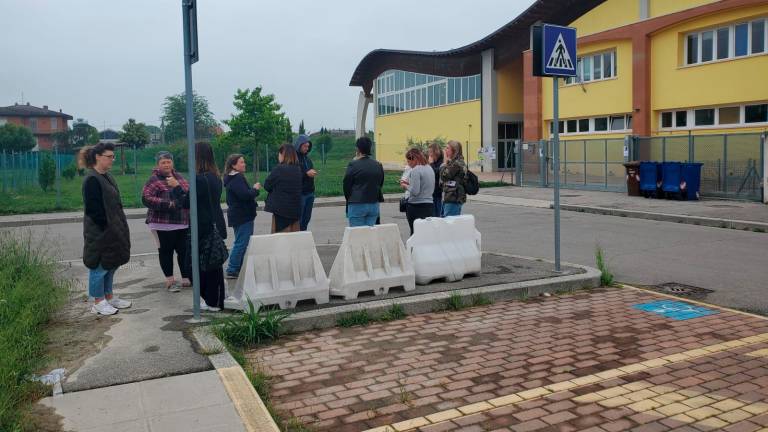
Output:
top-left (264, 164), bottom-right (303, 220)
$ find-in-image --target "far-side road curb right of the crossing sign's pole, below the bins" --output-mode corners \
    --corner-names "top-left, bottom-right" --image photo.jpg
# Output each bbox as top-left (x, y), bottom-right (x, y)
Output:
top-left (550, 204), bottom-right (768, 232)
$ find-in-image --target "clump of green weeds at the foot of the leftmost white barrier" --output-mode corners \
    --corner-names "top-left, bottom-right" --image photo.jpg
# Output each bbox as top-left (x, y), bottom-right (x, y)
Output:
top-left (213, 299), bottom-right (289, 347)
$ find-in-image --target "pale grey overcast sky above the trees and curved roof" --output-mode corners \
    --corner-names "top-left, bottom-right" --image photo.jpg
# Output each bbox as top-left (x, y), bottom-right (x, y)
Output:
top-left (0, 0), bottom-right (533, 130)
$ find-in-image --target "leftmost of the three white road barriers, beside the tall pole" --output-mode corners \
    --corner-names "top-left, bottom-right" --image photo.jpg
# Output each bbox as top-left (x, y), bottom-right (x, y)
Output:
top-left (225, 231), bottom-right (329, 309)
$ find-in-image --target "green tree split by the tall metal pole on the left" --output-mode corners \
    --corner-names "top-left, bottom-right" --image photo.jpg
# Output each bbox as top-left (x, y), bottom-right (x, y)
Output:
top-left (161, 93), bottom-right (217, 143)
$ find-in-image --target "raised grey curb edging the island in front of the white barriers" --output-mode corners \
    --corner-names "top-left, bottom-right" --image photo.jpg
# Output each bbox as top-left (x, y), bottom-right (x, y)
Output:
top-left (283, 252), bottom-right (601, 332)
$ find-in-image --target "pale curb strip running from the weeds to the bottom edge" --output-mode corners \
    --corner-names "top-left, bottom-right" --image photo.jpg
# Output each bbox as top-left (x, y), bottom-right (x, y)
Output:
top-left (193, 327), bottom-right (280, 432)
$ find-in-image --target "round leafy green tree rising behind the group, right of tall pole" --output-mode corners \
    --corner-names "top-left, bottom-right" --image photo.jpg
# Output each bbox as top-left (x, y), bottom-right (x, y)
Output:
top-left (224, 87), bottom-right (290, 171)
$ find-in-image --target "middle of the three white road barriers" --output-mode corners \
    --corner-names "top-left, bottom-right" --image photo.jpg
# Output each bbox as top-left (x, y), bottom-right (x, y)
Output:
top-left (330, 224), bottom-right (416, 300)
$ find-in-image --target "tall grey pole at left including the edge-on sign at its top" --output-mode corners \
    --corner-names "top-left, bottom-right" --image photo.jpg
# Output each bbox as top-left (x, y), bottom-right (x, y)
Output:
top-left (181, 0), bottom-right (200, 321)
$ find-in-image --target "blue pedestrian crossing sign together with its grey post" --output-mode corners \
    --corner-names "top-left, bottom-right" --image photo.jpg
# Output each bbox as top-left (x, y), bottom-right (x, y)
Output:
top-left (531, 24), bottom-right (576, 272)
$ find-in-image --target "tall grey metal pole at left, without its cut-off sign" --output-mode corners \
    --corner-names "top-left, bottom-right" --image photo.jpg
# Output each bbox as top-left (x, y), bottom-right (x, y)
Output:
top-left (181, 0), bottom-right (200, 320)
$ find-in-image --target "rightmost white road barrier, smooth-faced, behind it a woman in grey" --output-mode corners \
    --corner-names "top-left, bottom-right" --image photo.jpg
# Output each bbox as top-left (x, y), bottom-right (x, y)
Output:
top-left (406, 215), bottom-right (482, 285)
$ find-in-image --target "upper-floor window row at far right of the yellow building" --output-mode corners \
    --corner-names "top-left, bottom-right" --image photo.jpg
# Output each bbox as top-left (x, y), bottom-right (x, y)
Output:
top-left (685, 18), bottom-right (768, 65)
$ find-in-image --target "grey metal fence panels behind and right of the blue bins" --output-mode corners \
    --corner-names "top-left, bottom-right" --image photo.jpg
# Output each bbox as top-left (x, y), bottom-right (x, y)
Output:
top-left (635, 133), bottom-right (766, 200)
